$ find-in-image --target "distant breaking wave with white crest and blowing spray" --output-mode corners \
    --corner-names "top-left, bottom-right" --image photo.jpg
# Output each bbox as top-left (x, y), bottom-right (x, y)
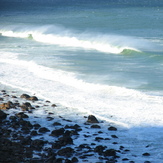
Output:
top-left (0, 26), bottom-right (143, 54)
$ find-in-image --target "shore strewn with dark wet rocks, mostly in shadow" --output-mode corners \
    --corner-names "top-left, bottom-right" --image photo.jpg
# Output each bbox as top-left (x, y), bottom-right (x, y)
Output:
top-left (0, 90), bottom-right (150, 163)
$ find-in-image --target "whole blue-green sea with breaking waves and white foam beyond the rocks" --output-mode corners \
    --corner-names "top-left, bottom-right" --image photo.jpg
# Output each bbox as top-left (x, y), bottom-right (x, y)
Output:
top-left (0, 0), bottom-right (163, 162)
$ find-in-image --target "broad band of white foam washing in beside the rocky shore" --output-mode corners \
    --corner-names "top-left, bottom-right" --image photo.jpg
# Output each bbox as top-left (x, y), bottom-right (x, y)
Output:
top-left (0, 57), bottom-right (163, 127)
